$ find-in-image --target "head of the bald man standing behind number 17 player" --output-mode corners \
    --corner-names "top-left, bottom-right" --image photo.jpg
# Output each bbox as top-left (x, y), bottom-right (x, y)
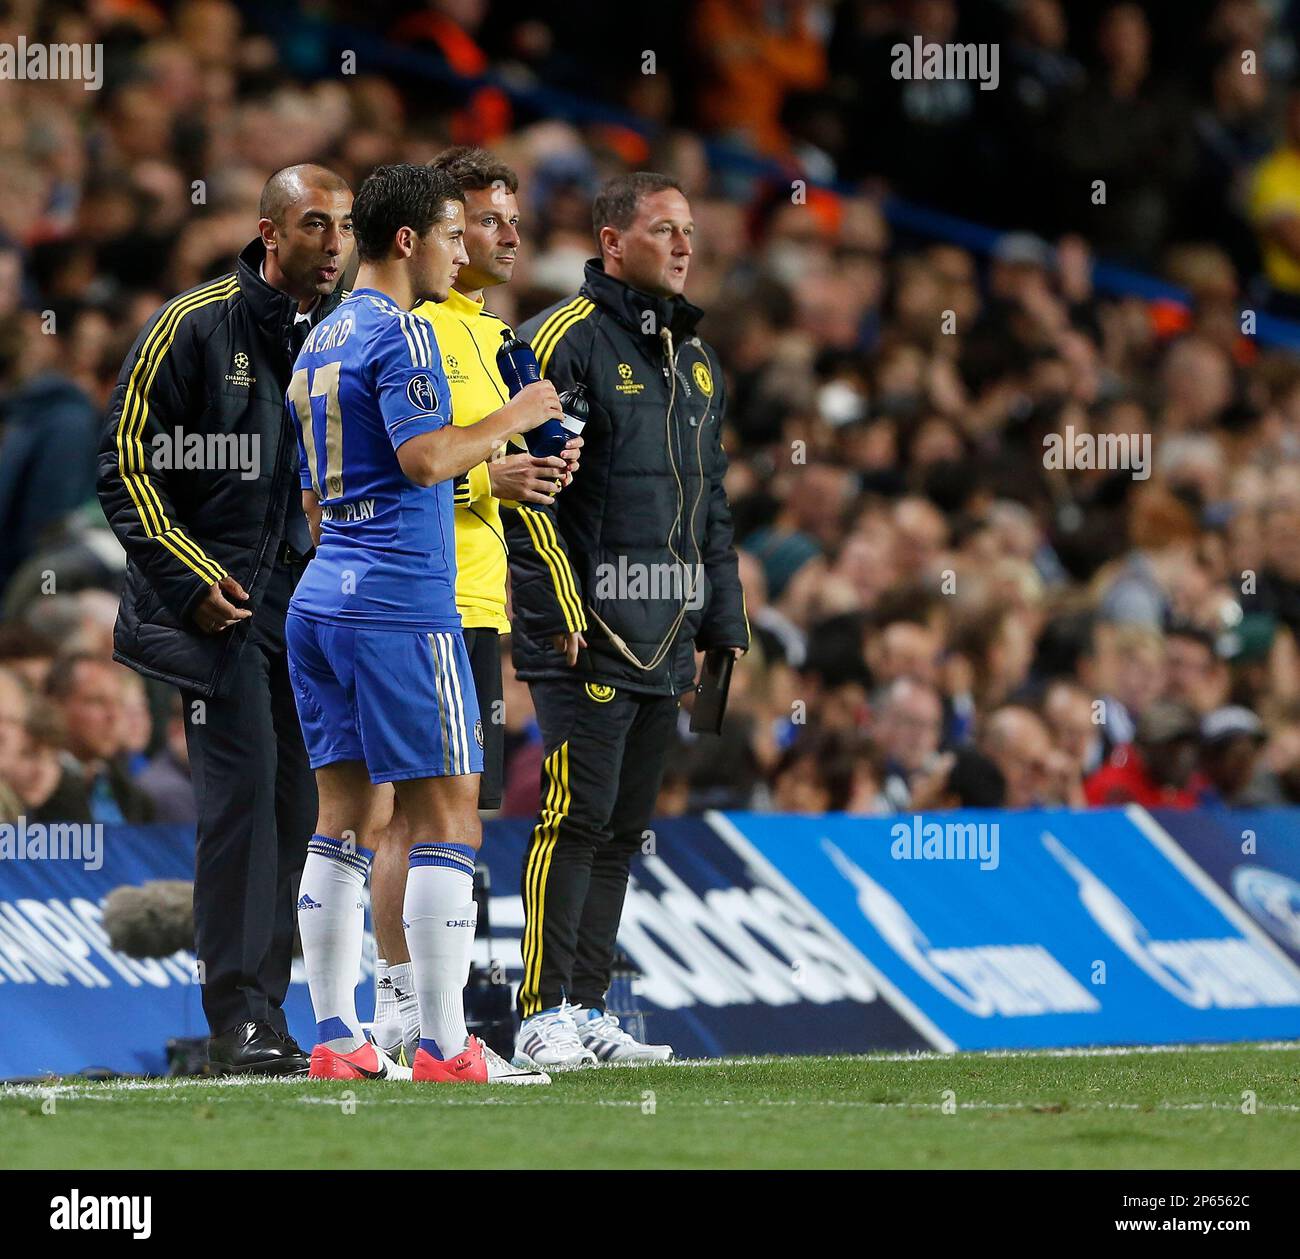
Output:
top-left (257, 163), bottom-right (354, 311)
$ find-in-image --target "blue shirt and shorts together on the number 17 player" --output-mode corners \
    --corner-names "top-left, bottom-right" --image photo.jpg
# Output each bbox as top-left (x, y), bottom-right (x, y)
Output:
top-left (289, 289), bottom-right (482, 783)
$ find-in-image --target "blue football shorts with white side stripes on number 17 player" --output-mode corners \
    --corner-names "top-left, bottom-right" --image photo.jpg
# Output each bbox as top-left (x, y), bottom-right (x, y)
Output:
top-left (285, 613), bottom-right (484, 783)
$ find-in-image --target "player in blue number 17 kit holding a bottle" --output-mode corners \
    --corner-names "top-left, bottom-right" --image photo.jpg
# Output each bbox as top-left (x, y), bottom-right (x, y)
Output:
top-left (285, 164), bottom-right (562, 1083)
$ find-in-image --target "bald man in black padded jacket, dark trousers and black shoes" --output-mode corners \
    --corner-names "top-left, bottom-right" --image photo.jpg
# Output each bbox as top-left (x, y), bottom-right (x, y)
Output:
top-left (99, 166), bottom-right (352, 1073)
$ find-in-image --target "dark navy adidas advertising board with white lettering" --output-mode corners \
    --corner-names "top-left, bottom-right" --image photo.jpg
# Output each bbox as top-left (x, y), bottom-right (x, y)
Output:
top-left (480, 817), bottom-right (932, 1057)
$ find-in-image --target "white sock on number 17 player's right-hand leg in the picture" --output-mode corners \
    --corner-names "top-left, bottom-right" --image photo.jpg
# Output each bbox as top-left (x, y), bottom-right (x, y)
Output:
top-left (402, 844), bottom-right (478, 1060)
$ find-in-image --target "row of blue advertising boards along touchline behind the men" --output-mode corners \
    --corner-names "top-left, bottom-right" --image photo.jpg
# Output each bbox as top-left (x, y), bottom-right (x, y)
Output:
top-left (0, 808), bottom-right (1300, 1078)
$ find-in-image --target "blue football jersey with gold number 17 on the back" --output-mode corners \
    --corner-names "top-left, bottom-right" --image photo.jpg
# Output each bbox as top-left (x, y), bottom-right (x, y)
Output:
top-left (287, 289), bottom-right (460, 631)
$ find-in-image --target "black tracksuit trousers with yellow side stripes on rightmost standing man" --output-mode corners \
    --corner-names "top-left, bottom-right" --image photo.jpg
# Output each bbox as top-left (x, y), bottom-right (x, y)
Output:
top-left (519, 678), bottom-right (677, 1018)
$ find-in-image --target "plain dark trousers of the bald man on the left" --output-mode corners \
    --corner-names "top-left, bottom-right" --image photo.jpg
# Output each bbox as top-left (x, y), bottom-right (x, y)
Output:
top-left (183, 564), bottom-right (316, 1035)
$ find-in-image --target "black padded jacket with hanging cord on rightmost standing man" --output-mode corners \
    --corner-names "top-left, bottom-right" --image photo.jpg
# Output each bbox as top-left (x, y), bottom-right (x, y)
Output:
top-left (503, 259), bottom-right (749, 695)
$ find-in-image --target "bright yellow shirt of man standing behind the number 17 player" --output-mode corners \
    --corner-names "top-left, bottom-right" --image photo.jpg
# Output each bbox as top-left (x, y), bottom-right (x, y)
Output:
top-left (415, 289), bottom-right (510, 633)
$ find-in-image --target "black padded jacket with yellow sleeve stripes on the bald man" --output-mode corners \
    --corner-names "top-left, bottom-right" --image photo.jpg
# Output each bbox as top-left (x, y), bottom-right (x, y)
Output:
top-left (98, 241), bottom-right (342, 697)
